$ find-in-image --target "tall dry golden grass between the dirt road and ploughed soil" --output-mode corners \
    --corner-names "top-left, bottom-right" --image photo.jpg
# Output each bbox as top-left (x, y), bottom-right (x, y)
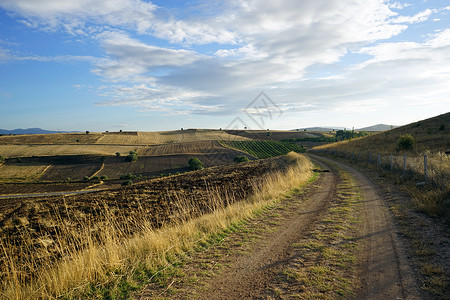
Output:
top-left (0, 153), bottom-right (311, 299)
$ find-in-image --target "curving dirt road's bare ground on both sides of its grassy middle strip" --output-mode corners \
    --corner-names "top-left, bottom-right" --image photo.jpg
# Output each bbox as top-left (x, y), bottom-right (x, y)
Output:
top-left (136, 156), bottom-right (423, 299)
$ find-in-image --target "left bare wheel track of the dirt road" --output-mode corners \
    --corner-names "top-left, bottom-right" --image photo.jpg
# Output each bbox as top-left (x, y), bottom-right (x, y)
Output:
top-left (198, 164), bottom-right (338, 299)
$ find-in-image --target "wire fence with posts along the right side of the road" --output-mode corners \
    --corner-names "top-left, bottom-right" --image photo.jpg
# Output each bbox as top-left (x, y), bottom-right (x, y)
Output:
top-left (309, 149), bottom-right (450, 189)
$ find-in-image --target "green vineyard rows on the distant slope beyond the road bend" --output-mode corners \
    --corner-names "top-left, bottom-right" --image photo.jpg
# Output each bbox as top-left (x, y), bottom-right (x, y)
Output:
top-left (221, 141), bottom-right (305, 158)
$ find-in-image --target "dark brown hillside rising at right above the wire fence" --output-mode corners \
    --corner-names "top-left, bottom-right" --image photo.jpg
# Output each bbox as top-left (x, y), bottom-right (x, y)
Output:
top-left (315, 113), bottom-right (450, 154)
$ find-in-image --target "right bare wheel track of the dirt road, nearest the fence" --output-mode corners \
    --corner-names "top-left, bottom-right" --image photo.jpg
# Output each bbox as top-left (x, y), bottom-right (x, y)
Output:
top-left (311, 155), bottom-right (422, 299)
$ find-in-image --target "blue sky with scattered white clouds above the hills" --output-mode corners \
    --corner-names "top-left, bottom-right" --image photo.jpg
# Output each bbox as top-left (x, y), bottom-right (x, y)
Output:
top-left (0, 0), bottom-right (450, 132)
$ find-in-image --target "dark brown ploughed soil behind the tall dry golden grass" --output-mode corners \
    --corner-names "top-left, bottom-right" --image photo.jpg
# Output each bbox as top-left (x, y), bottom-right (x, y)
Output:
top-left (0, 157), bottom-right (287, 284)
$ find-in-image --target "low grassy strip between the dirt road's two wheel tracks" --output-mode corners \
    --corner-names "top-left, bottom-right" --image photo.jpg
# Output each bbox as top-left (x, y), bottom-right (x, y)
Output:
top-left (283, 170), bottom-right (360, 299)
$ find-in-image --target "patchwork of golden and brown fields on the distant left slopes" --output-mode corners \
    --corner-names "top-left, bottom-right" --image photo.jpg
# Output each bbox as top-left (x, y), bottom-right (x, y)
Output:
top-left (0, 130), bottom-right (250, 193)
